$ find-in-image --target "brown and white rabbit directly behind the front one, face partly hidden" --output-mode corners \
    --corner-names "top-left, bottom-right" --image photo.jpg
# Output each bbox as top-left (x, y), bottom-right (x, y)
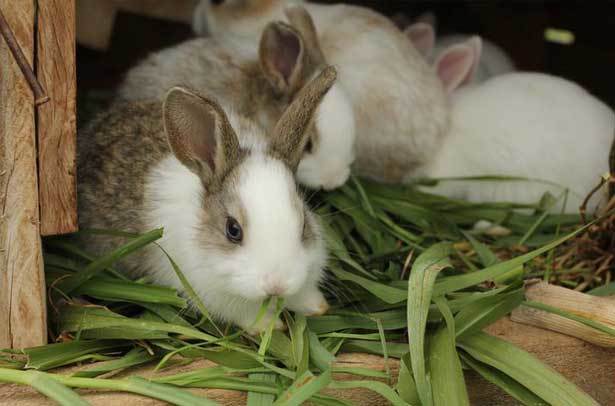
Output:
top-left (119, 10), bottom-right (355, 190)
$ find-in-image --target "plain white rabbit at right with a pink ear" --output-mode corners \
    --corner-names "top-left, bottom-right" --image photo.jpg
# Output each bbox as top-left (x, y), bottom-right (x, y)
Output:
top-left (407, 37), bottom-right (615, 211)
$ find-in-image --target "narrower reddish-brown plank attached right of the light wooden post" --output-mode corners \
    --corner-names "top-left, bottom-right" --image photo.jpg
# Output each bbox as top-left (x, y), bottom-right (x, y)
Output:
top-left (36, 0), bottom-right (77, 235)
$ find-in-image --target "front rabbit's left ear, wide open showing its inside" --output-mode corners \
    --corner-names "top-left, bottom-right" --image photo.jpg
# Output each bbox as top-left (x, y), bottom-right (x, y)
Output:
top-left (163, 87), bottom-right (240, 187)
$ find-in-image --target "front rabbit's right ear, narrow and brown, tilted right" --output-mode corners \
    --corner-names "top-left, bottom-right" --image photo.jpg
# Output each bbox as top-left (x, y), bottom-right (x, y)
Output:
top-left (270, 66), bottom-right (337, 172)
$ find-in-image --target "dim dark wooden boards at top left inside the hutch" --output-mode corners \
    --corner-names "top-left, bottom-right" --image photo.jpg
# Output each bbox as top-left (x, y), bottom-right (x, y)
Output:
top-left (77, 0), bottom-right (199, 51)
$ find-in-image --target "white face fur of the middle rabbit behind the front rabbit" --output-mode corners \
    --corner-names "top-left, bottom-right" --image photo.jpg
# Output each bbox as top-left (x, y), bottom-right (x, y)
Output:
top-left (297, 83), bottom-right (355, 190)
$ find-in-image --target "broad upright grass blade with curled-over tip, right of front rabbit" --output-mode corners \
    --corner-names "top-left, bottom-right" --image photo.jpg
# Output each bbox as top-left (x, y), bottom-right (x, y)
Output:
top-left (407, 243), bottom-right (452, 406)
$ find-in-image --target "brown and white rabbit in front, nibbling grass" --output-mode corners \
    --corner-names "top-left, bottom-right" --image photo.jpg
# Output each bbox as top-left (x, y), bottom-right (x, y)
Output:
top-left (79, 67), bottom-right (336, 332)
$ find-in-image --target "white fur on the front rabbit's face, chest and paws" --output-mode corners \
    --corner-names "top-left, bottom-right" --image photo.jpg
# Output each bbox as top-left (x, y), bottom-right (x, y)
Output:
top-left (145, 142), bottom-right (326, 328)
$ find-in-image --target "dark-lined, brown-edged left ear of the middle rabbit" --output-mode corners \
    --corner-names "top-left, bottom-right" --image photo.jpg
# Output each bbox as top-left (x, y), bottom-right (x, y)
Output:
top-left (259, 22), bottom-right (305, 94)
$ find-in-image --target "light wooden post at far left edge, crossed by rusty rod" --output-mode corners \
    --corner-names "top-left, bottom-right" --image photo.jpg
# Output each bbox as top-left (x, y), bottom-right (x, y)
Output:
top-left (0, 0), bottom-right (47, 348)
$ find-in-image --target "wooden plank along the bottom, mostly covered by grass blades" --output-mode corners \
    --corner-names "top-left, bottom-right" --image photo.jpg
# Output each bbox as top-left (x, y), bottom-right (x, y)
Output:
top-left (0, 319), bottom-right (615, 406)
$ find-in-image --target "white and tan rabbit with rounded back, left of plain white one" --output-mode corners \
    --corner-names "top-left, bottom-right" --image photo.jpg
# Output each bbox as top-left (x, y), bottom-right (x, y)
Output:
top-left (194, 0), bottom-right (448, 182)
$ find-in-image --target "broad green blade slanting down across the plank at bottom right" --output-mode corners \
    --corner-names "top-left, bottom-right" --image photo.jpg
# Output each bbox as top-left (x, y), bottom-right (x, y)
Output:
top-left (457, 332), bottom-right (598, 406)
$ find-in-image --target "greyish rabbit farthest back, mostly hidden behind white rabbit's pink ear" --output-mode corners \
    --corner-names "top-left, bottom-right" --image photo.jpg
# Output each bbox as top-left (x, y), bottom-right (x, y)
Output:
top-left (404, 17), bottom-right (516, 83)
